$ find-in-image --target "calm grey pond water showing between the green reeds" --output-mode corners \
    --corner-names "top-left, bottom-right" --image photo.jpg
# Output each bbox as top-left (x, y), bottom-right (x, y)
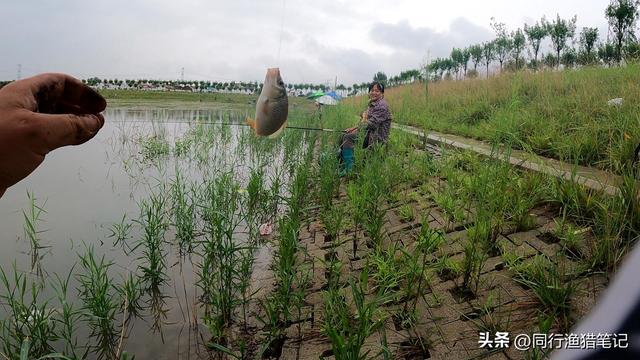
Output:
top-left (0, 107), bottom-right (304, 359)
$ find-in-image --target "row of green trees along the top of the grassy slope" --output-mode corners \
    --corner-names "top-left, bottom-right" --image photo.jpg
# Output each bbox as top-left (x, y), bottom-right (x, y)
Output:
top-left (373, 0), bottom-right (640, 86)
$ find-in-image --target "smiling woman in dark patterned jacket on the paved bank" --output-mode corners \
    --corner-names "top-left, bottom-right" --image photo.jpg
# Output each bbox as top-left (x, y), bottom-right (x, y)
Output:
top-left (340, 81), bottom-right (392, 177)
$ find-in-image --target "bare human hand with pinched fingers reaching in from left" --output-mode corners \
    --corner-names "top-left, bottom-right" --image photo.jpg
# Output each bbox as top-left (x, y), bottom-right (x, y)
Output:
top-left (0, 73), bottom-right (107, 196)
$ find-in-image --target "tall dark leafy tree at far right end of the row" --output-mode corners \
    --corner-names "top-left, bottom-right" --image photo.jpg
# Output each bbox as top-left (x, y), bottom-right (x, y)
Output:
top-left (605, 0), bottom-right (640, 63)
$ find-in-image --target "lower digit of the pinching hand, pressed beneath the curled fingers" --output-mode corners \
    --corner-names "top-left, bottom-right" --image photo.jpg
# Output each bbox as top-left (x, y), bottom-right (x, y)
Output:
top-left (36, 114), bottom-right (104, 153)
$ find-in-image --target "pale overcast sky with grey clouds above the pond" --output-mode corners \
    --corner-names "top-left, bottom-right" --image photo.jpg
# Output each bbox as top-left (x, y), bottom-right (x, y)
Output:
top-left (0, 0), bottom-right (609, 85)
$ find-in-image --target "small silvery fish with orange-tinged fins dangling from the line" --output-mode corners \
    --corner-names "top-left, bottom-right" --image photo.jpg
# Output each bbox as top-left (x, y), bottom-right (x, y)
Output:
top-left (247, 68), bottom-right (289, 137)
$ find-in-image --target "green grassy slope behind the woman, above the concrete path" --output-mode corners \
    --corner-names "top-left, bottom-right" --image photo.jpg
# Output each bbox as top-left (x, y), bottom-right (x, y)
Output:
top-left (342, 65), bottom-right (640, 173)
